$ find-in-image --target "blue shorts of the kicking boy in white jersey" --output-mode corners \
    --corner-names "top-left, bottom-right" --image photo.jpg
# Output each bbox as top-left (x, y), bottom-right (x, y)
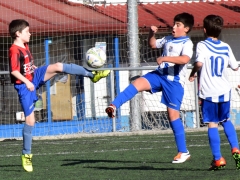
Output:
top-left (142, 70), bottom-right (184, 111)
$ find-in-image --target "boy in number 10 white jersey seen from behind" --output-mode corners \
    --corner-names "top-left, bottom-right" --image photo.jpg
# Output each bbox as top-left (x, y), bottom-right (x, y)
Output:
top-left (189, 15), bottom-right (240, 170)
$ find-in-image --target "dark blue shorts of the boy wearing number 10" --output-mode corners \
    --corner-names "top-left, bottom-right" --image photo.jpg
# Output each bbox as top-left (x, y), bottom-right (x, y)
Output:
top-left (202, 99), bottom-right (230, 123)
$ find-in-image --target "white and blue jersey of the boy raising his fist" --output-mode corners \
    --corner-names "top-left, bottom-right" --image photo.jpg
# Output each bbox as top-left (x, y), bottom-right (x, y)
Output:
top-left (156, 36), bottom-right (193, 86)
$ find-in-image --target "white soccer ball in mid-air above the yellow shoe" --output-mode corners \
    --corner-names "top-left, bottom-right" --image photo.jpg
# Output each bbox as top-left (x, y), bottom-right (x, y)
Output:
top-left (86, 47), bottom-right (107, 68)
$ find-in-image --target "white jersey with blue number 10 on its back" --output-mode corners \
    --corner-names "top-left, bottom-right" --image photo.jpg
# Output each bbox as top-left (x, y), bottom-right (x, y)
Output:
top-left (196, 38), bottom-right (238, 102)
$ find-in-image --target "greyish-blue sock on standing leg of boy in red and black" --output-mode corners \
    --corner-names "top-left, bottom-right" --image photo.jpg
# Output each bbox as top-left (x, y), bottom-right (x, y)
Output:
top-left (22, 124), bottom-right (33, 154)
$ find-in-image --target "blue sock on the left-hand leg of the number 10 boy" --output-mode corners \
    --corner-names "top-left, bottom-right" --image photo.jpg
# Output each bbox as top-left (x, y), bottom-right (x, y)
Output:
top-left (208, 128), bottom-right (222, 160)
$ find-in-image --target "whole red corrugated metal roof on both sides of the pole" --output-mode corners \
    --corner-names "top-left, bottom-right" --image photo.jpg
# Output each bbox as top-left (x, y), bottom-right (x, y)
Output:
top-left (0, 0), bottom-right (240, 34)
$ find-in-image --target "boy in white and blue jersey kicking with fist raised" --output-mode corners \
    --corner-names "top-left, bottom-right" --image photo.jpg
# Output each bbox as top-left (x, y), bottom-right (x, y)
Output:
top-left (106, 13), bottom-right (194, 163)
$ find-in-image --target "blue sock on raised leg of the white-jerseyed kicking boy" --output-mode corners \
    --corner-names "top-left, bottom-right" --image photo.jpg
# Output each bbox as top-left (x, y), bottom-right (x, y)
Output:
top-left (112, 84), bottom-right (138, 108)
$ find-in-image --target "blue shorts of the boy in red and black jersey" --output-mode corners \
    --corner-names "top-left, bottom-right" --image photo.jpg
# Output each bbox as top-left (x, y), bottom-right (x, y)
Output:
top-left (14, 66), bottom-right (48, 117)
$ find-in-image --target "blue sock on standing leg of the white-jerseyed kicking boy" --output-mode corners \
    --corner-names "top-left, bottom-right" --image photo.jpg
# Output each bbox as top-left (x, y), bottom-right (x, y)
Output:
top-left (170, 118), bottom-right (188, 153)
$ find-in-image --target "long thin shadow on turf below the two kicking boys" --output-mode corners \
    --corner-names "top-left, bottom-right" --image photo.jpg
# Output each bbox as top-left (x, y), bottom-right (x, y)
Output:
top-left (61, 159), bottom-right (171, 166)
